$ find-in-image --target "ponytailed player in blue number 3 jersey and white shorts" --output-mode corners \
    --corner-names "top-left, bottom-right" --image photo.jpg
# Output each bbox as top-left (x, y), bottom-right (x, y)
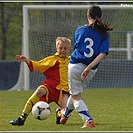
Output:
top-left (60, 5), bottom-right (113, 128)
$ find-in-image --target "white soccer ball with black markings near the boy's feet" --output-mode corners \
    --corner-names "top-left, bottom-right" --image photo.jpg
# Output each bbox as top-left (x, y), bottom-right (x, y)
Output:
top-left (32, 101), bottom-right (51, 120)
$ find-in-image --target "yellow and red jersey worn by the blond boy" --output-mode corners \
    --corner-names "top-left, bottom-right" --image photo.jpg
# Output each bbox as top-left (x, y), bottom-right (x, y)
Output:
top-left (29, 52), bottom-right (70, 92)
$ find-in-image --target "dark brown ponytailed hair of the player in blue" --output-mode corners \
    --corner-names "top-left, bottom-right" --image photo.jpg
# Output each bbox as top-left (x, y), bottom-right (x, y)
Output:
top-left (87, 5), bottom-right (114, 35)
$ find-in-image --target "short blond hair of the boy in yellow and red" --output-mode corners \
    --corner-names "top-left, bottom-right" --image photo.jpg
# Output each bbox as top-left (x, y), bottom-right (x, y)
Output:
top-left (56, 37), bottom-right (71, 47)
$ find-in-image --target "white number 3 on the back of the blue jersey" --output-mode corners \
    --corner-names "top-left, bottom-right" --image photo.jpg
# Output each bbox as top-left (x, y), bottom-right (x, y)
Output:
top-left (84, 38), bottom-right (94, 58)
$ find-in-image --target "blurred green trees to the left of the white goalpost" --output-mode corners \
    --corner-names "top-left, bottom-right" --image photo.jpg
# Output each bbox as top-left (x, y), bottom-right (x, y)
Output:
top-left (0, 2), bottom-right (42, 61)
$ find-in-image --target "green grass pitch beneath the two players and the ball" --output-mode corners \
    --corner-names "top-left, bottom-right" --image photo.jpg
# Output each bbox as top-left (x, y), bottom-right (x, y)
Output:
top-left (0, 88), bottom-right (133, 132)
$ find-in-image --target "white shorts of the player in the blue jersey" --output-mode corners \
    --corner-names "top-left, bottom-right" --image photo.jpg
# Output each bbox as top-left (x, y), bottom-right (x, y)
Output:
top-left (68, 63), bottom-right (97, 95)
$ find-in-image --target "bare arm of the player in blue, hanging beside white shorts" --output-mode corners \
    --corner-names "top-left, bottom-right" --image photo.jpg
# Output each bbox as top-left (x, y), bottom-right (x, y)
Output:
top-left (81, 53), bottom-right (106, 80)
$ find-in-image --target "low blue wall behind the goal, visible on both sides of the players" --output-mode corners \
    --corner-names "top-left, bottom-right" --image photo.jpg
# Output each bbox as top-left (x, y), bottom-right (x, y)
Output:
top-left (0, 60), bottom-right (133, 90)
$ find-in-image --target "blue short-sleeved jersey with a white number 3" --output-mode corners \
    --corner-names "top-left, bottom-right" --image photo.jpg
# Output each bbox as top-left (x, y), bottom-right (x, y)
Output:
top-left (70, 26), bottom-right (109, 68)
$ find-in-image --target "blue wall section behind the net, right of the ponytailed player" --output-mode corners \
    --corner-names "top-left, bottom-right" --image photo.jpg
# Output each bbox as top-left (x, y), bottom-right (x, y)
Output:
top-left (89, 60), bottom-right (133, 88)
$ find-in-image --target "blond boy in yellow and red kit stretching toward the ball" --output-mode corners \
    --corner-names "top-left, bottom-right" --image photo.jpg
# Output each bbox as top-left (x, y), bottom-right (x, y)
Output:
top-left (10, 37), bottom-right (71, 126)
